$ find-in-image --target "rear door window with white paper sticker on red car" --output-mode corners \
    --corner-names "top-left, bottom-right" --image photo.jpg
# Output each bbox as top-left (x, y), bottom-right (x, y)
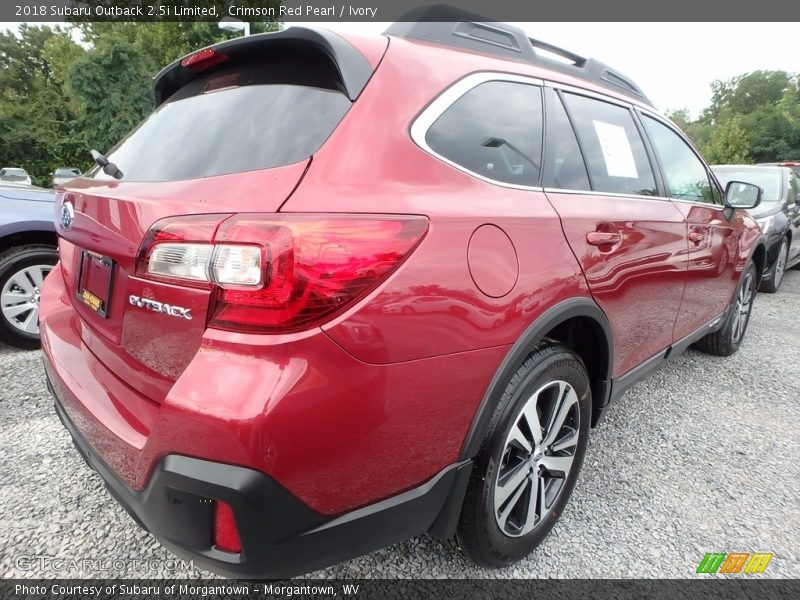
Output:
top-left (564, 94), bottom-right (657, 196)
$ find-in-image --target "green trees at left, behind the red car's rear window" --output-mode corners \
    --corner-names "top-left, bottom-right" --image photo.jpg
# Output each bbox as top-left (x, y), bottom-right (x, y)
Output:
top-left (0, 22), bottom-right (277, 186)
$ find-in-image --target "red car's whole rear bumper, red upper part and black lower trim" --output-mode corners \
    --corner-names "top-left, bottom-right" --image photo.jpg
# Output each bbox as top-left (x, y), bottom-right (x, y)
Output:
top-left (40, 267), bottom-right (482, 578)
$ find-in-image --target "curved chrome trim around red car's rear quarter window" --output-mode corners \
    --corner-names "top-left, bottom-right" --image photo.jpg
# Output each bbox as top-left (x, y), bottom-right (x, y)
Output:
top-left (410, 71), bottom-right (544, 192)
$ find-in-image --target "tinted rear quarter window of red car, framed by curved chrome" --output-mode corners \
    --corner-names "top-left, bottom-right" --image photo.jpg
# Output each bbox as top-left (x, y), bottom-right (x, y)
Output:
top-left (425, 81), bottom-right (543, 186)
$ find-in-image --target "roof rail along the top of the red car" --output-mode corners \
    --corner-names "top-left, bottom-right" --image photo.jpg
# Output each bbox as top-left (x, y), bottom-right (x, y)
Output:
top-left (386, 5), bottom-right (653, 106)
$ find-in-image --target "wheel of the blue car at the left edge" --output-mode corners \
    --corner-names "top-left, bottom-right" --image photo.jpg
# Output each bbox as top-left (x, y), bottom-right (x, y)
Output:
top-left (0, 245), bottom-right (58, 350)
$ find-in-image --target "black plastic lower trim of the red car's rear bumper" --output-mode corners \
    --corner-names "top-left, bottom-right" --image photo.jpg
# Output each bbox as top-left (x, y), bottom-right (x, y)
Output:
top-left (48, 381), bottom-right (472, 579)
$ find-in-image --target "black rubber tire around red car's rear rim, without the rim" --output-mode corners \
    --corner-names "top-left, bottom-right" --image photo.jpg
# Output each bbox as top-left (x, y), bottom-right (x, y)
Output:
top-left (468, 351), bottom-right (591, 563)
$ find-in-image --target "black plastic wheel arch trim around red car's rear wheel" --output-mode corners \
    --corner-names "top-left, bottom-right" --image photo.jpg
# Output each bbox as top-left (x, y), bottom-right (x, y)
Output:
top-left (459, 297), bottom-right (614, 460)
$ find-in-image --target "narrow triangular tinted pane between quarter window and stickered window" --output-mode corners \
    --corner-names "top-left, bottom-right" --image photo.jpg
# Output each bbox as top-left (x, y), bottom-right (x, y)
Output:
top-left (544, 96), bottom-right (592, 190)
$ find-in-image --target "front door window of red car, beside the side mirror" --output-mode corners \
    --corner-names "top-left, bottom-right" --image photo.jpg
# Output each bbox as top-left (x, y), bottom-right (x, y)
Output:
top-left (642, 115), bottom-right (717, 204)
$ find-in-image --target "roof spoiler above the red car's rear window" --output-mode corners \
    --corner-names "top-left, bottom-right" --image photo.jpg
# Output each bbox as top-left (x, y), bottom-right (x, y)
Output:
top-left (153, 27), bottom-right (373, 107)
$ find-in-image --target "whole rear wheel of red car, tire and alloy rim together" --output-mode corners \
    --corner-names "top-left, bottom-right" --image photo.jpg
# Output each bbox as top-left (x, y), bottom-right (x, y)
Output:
top-left (457, 340), bottom-right (592, 567)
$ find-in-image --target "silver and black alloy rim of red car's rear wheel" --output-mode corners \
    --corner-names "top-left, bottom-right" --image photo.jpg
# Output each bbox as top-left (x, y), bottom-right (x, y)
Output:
top-left (494, 380), bottom-right (580, 537)
